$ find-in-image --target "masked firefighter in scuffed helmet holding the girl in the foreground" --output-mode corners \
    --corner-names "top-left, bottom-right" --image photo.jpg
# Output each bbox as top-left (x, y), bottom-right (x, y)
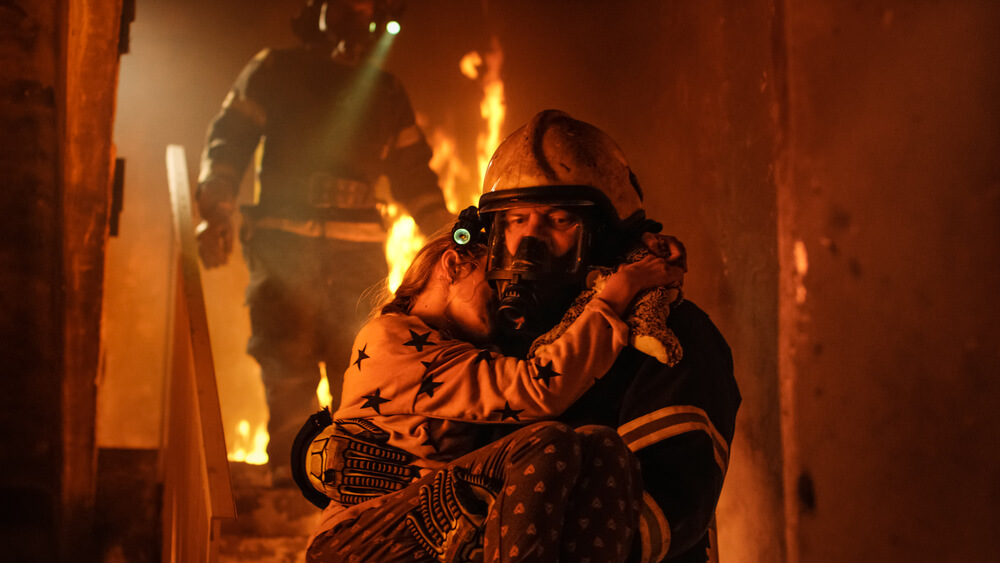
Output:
top-left (293, 110), bottom-right (741, 563)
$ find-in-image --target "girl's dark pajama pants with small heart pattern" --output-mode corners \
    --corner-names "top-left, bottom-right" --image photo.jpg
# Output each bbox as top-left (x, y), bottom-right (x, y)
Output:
top-left (307, 422), bottom-right (642, 563)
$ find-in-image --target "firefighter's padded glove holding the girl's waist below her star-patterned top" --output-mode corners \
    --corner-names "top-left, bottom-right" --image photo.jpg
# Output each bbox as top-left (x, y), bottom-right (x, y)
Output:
top-left (306, 418), bottom-right (420, 505)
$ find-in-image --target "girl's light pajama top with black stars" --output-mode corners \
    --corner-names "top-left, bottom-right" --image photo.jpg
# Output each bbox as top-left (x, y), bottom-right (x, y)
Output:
top-left (333, 299), bottom-right (628, 469)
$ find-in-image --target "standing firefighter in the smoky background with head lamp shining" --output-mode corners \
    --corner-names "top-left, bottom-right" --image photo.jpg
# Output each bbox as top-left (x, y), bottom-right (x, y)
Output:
top-left (197, 0), bottom-right (452, 485)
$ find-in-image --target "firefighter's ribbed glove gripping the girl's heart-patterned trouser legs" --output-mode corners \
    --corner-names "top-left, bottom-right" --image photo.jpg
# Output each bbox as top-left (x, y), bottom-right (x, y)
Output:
top-left (406, 467), bottom-right (496, 563)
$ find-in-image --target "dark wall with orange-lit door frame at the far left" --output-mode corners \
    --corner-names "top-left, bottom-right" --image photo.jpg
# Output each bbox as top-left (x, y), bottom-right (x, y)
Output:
top-left (0, 1), bottom-right (121, 561)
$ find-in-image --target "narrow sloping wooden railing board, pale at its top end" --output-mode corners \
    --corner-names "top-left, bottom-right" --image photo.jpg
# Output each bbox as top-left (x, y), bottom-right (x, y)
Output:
top-left (167, 145), bottom-right (236, 518)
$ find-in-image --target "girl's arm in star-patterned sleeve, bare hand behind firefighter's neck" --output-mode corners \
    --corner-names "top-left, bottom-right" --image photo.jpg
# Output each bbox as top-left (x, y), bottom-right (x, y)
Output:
top-left (335, 257), bottom-right (676, 423)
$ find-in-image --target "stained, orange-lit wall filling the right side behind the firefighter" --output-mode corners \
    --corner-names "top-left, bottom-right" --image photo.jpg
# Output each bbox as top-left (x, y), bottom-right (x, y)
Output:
top-left (779, 1), bottom-right (1000, 562)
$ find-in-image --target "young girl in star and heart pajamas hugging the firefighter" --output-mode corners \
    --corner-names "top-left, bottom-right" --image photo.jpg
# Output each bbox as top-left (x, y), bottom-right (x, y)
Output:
top-left (308, 229), bottom-right (681, 562)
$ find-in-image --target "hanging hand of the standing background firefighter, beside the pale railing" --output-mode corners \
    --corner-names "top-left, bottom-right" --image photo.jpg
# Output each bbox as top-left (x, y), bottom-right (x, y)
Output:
top-left (195, 178), bottom-right (236, 269)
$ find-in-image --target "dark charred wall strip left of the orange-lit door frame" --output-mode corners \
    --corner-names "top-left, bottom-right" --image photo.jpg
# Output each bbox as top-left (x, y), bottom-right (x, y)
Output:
top-left (0, 2), bottom-right (64, 561)
